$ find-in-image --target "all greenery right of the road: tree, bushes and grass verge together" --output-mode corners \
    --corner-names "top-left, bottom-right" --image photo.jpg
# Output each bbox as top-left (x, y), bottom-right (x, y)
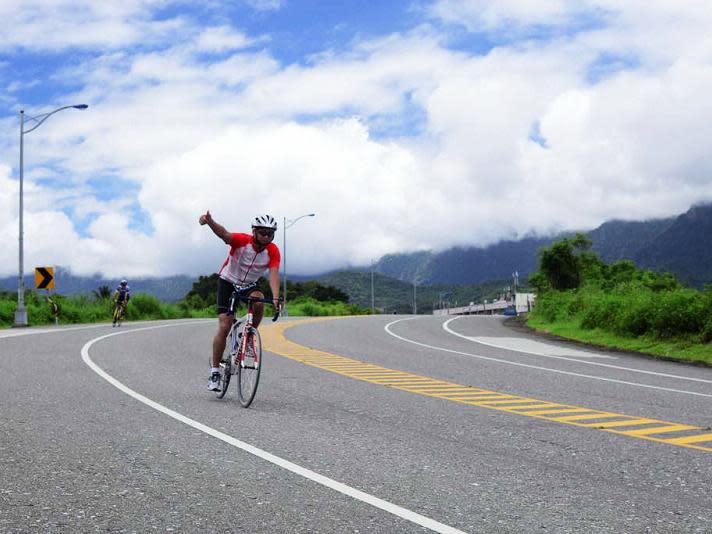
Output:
top-left (528, 234), bottom-right (712, 364)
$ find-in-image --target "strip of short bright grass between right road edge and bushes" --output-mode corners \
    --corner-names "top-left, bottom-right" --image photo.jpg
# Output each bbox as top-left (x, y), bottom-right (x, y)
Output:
top-left (527, 316), bottom-right (712, 365)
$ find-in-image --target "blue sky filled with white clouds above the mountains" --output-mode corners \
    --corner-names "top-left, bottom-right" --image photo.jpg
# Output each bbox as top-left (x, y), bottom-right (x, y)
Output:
top-left (0, 0), bottom-right (712, 276)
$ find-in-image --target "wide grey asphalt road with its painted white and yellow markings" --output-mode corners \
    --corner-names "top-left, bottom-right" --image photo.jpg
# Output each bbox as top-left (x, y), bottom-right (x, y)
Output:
top-left (0, 316), bottom-right (712, 533)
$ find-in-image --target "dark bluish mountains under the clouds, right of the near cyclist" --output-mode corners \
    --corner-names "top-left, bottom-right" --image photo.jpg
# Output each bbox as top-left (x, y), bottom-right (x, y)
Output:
top-left (374, 204), bottom-right (712, 287)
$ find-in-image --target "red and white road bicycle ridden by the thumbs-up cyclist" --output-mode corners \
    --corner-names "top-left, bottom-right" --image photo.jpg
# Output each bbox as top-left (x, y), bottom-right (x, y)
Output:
top-left (217, 284), bottom-right (281, 408)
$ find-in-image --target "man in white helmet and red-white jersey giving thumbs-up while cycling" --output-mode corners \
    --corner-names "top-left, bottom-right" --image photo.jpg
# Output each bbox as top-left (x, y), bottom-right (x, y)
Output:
top-left (198, 211), bottom-right (280, 391)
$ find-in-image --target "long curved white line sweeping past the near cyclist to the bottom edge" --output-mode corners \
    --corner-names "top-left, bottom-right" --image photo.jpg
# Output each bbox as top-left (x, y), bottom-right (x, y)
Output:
top-left (81, 324), bottom-right (465, 534)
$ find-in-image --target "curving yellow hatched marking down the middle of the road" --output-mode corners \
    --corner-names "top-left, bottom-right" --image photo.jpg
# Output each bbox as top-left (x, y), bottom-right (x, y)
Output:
top-left (260, 317), bottom-right (712, 452)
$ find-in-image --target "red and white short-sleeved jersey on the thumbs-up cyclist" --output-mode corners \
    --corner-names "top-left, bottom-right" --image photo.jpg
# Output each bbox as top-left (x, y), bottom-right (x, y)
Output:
top-left (218, 234), bottom-right (280, 285)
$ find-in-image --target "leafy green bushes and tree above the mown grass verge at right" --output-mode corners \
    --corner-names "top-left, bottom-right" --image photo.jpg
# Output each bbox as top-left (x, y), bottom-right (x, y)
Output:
top-left (530, 240), bottom-right (712, 346)
